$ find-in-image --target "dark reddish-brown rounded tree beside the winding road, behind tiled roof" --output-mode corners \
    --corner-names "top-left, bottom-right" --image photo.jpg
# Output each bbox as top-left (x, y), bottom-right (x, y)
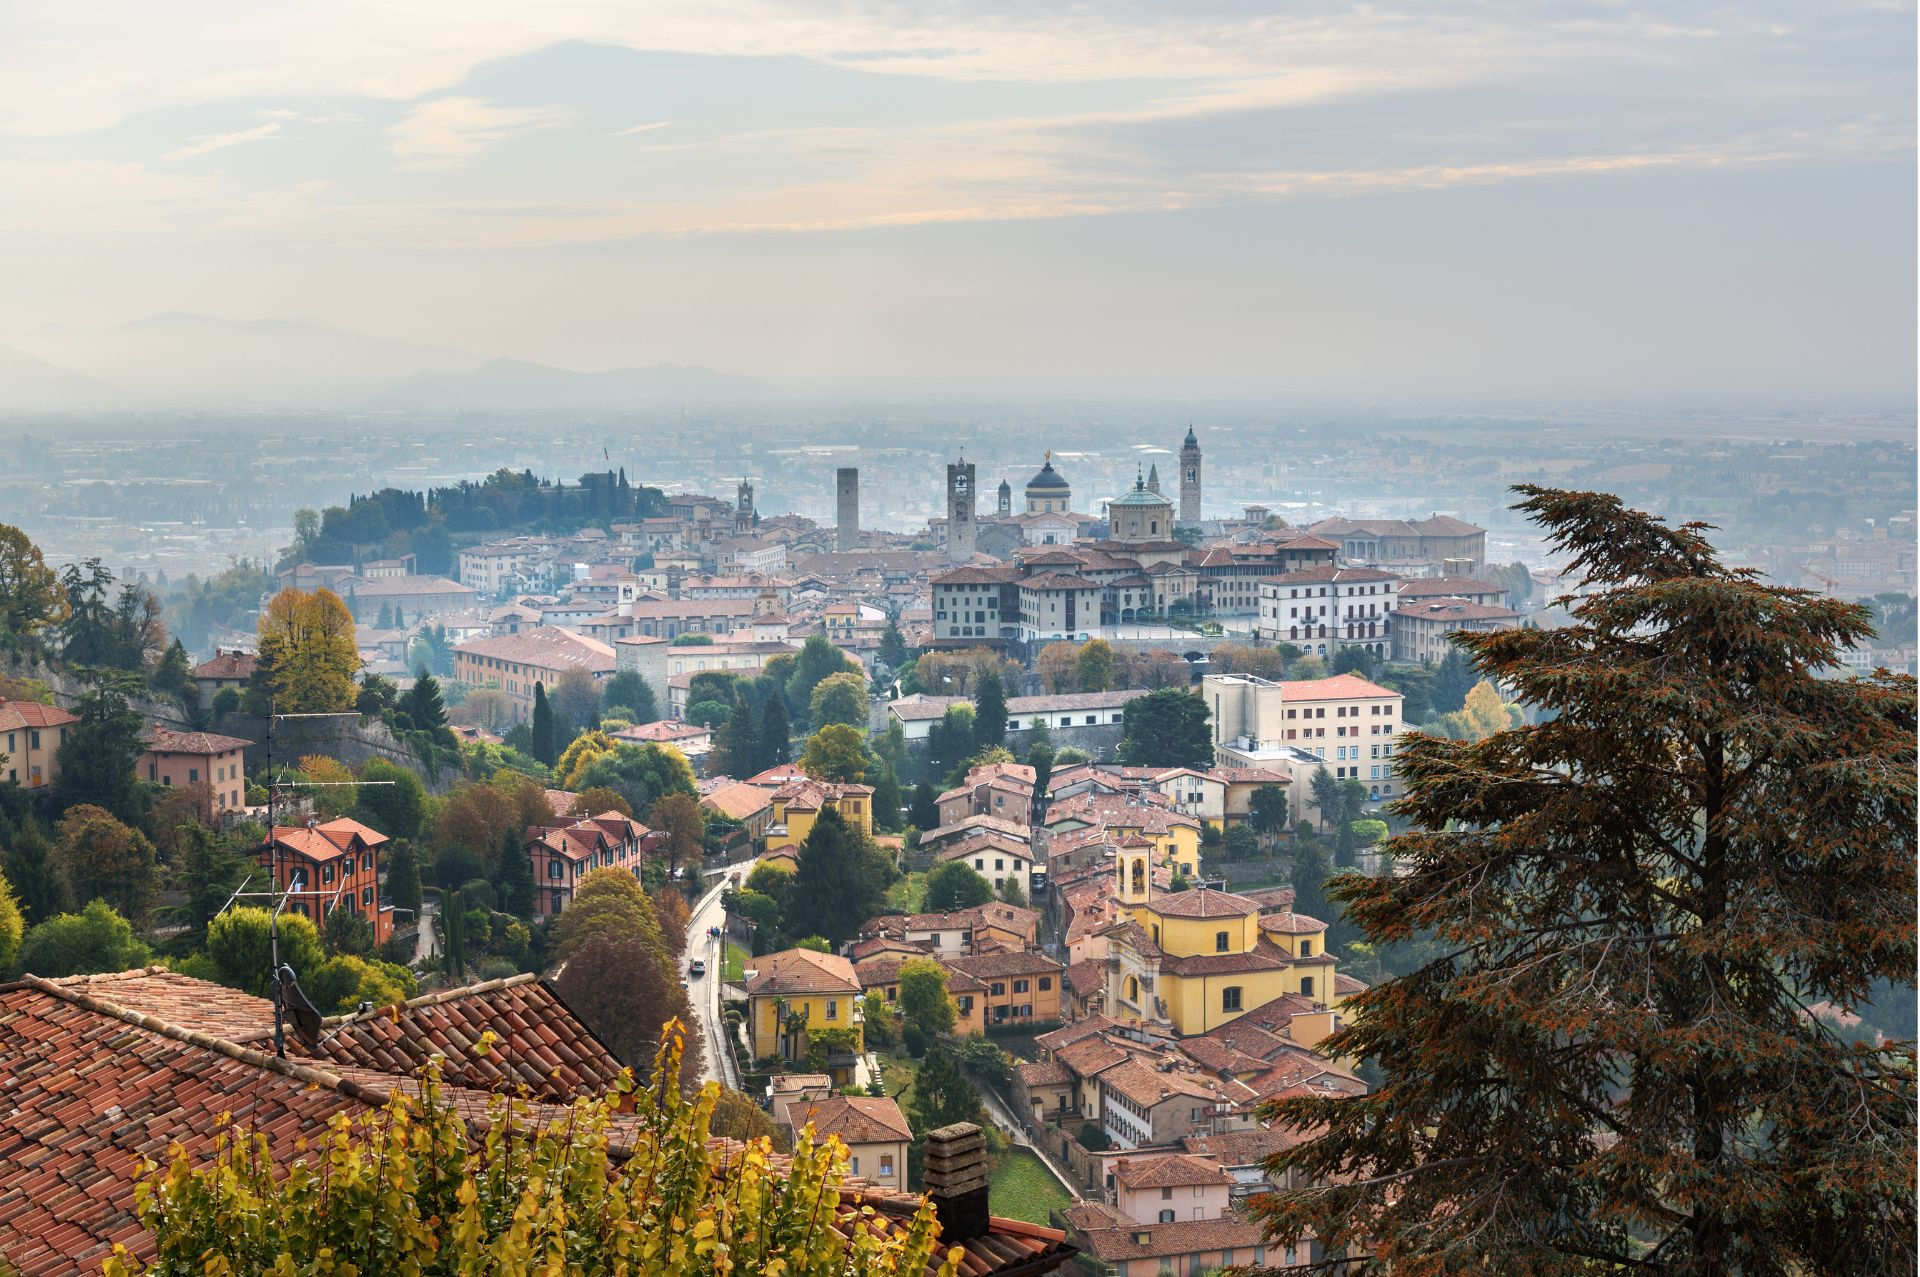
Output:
top-left (555, 933), bottom-right (701, 1091)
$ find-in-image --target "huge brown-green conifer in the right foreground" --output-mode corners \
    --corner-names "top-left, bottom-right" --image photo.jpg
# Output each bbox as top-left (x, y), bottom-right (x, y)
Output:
top-left (1256, 488), bottom-right (1920, 1273)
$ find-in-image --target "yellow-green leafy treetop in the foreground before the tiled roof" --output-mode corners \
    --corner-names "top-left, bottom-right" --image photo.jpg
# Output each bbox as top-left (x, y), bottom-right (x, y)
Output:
top-left (108, 1022), bottom-right (939, 1277)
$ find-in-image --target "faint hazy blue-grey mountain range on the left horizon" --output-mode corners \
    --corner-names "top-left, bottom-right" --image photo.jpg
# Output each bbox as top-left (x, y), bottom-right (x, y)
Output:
top-left (0, 313), bottom-right (768, 417)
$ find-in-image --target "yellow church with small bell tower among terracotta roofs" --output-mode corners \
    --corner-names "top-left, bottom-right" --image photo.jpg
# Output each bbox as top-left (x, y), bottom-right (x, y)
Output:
top-left (1106, 845), bottom-right (1342, 1045)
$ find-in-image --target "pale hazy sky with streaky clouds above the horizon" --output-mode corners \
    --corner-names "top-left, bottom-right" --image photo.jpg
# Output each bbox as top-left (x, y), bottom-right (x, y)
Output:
top-left (0, 0), bottom-right (1916, 398)
